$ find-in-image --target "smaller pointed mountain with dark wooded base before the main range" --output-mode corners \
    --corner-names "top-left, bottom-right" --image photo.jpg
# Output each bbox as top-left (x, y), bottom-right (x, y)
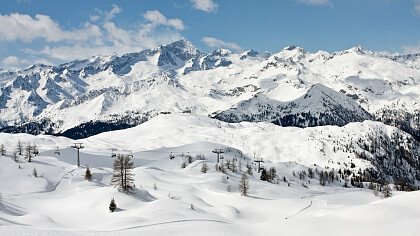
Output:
top-left (215, 84), bottom-right (371, 127)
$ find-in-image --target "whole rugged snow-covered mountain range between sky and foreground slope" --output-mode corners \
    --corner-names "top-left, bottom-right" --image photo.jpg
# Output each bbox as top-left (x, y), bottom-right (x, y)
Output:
top-left (0, 39), bottom-right (420, 138)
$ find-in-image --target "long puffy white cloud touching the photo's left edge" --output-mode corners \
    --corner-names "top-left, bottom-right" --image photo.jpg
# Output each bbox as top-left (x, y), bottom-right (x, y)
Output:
top-left (0, 13), bottom-right (101, 42)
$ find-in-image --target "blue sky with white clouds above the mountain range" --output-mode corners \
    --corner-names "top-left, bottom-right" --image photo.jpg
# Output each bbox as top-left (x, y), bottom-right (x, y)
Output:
top-left (0, 0), bottom-right (420, 68)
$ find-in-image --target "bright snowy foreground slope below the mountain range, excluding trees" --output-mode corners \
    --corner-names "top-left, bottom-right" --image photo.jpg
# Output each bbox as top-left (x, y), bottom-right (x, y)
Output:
top-left (0, 114), bottom-right (420, 236)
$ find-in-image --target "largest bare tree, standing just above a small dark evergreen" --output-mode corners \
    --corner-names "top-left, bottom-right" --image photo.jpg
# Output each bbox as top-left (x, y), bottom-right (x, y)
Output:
top-left (111, 154), bottom-right (134, 192)
